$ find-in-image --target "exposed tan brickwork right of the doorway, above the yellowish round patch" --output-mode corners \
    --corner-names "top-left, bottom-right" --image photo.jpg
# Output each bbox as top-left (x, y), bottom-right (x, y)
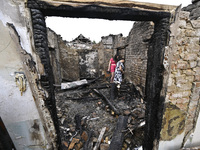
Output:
top-left (167, 7), bottom-right (200, 143)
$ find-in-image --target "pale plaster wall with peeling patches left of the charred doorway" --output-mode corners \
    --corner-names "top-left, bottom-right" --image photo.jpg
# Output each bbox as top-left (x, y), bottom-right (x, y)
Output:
top-left (0, 0), bottom-right (55, 150)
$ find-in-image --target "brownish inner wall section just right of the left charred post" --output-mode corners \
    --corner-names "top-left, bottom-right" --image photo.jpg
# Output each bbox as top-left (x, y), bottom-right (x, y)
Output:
top-left (47, 29), bottom-right (80, 84)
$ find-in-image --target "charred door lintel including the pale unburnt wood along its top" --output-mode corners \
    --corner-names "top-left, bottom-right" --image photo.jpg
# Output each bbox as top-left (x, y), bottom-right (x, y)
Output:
top-left (28, 0), bottom-right (176, 21)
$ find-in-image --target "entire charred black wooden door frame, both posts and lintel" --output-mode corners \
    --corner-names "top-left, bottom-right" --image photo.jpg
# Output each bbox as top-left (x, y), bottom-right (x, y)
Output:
top-left (27, 0), bottom-right (171, 150)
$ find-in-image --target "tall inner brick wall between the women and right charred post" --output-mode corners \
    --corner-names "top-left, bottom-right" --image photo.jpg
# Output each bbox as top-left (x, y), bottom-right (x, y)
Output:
top-left (125, 21), bottom-right (154, 95)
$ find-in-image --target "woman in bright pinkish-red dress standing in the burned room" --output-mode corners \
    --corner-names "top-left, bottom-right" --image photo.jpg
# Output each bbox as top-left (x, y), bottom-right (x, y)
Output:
top-left (108, 55), bottom-right (118, 83)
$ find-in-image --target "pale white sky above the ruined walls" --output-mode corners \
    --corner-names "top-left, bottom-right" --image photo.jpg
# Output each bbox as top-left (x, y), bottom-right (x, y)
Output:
top-left (46, 0), bottom-right (192, 42)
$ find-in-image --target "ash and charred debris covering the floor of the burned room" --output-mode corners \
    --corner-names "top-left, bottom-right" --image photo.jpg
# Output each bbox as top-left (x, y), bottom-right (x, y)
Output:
top-left (56, 76), bottom-right (145, 150)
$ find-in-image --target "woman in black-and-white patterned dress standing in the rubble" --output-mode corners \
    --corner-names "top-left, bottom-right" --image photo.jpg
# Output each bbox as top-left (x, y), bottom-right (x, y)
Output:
top-left (114, 58), bottom-right (124, 84)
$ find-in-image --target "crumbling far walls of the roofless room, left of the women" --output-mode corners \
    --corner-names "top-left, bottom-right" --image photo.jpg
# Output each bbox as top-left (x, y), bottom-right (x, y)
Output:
top-left (48, 29), bottom-right (126, 79)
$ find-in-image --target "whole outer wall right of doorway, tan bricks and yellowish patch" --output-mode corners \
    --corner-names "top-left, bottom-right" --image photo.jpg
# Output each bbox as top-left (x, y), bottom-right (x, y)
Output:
top-left (159, 2), bottom-right (200, 149)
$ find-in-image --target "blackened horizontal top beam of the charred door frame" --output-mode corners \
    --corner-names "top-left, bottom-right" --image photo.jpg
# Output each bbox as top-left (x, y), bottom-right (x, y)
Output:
top-left (28, 0), bottom-right (171, 21)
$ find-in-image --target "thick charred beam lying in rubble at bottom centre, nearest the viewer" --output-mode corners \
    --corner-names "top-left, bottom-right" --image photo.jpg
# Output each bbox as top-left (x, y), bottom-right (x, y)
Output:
top-left (108, 116), bottom-right (128, 150)
